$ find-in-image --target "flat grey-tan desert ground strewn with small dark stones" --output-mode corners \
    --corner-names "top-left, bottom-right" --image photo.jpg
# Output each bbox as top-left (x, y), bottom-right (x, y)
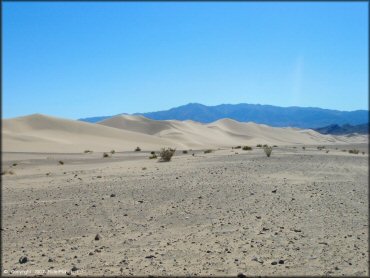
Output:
top-left (2, 144), bottom-right (369, 276)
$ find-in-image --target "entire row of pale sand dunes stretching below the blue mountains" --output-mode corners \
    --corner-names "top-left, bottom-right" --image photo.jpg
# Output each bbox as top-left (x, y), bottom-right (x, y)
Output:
top-left (2, 114), bottom-right (367, 153)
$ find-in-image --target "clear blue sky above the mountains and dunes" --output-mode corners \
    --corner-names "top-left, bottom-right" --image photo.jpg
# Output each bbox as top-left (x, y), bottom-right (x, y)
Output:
top-left (2, 2), bottom-right (369, 119)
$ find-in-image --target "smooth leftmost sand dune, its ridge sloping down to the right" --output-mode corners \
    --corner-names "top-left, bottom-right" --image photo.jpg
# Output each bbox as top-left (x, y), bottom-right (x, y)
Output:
top-left (2, 114), bottom-right (178, 153)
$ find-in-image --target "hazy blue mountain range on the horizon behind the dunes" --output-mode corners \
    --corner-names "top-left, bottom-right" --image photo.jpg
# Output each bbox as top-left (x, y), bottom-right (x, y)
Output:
top-left (81, 103), bottom-right (369, 128)
